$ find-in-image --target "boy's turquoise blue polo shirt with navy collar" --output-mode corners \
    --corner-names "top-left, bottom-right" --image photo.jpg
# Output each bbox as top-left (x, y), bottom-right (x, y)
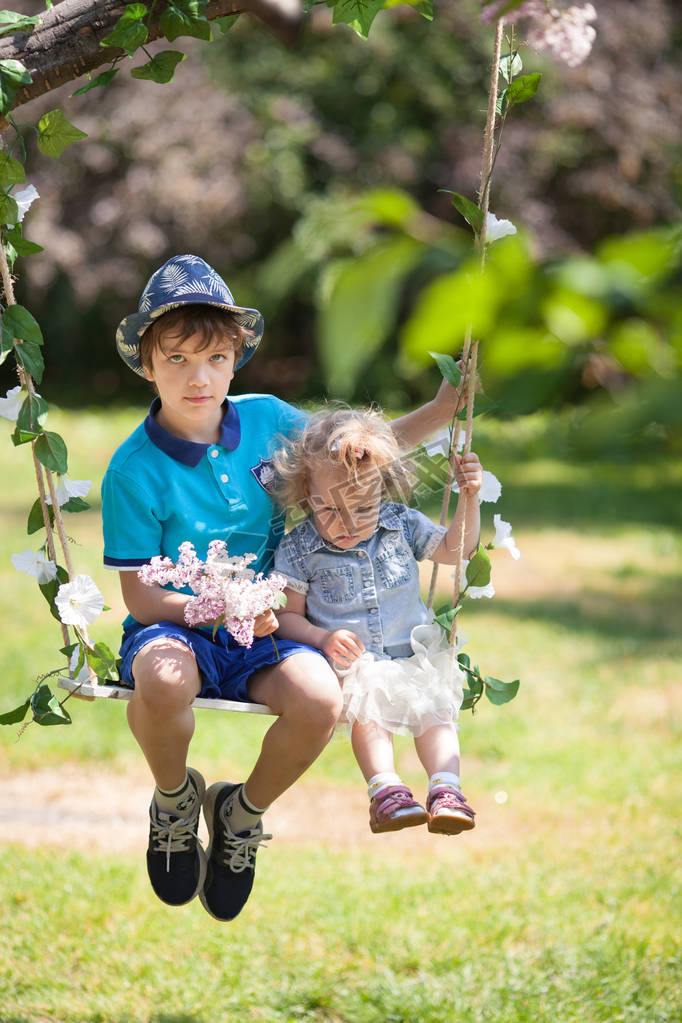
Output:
top-left (102, 394), bottom-right (307, 609)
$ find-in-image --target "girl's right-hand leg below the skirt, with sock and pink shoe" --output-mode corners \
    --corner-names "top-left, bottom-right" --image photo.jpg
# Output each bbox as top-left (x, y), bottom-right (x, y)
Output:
top-left (414, 724), bottom-right (474, 835)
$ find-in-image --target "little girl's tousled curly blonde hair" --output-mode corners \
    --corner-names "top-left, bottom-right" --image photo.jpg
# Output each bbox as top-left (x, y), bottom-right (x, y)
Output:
top-left (273, 408), bottom-right (411, 512)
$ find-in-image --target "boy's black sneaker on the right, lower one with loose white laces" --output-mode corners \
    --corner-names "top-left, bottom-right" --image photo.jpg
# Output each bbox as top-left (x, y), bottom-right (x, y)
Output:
top-left (199, 782), bottom-right (272, 920)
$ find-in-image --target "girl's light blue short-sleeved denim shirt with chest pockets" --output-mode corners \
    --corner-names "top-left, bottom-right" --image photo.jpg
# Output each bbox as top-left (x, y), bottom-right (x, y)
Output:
top-left (275, 503), bottom-right (447, 658)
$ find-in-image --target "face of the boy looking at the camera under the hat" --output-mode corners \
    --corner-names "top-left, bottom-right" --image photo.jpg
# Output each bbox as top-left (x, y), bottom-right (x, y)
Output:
top-left (144, 335), bottom-right (234, 443)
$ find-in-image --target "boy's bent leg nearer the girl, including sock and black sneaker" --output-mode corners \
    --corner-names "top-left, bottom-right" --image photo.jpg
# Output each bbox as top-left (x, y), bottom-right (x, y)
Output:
top-left (201, 653), bottom-right (343, 921)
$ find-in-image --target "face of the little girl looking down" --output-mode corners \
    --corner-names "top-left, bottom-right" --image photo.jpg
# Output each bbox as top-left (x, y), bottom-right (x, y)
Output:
top-left (306, 468), bottom-right (381, 550)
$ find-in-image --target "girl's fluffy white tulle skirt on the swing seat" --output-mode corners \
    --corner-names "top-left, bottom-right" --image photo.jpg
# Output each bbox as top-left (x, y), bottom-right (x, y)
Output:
top-left (336, 623), bottom-right (464, 736)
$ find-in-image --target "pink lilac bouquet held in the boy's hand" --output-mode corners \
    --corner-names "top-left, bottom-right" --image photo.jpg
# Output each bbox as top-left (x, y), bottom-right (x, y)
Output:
top-left (137, 540), bottom-right (286, 647)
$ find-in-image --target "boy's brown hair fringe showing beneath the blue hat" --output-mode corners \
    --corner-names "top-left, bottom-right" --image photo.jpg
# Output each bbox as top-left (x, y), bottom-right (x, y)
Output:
top-left (140, 303), bottom-right (246, 369)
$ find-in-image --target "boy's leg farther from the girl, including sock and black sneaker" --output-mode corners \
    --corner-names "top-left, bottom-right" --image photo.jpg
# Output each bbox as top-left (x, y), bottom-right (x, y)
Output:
top-left (128, 638), bottom-right (207, 905)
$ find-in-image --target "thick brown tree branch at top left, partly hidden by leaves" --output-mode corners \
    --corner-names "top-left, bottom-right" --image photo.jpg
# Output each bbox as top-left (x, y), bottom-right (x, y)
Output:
top-left (0, 0), bottom-right (303, 108)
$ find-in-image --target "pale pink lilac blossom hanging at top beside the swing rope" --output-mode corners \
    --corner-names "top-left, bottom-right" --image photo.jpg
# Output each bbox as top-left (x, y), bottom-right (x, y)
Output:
top-left (482, 0), bottom-right (597, 68)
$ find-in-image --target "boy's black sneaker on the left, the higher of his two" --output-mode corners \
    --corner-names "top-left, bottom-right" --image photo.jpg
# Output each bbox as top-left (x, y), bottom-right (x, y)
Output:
top-left (147, 767), bottom-right (207, 905)
